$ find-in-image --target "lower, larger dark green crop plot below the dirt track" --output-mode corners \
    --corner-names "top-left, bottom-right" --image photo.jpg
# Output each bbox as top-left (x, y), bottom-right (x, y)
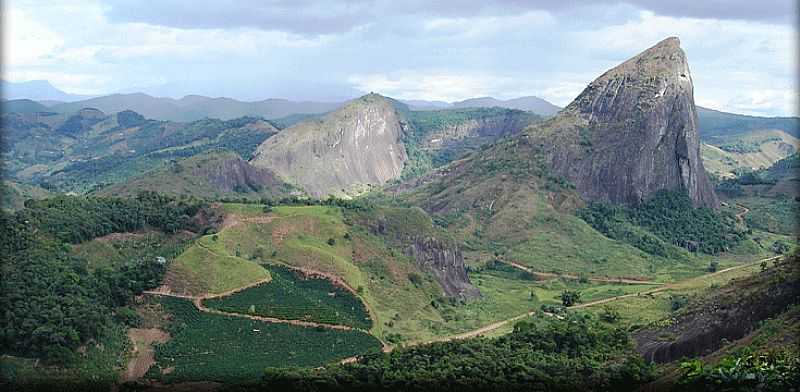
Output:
top-left (146, 297), bottom-right (381, 382)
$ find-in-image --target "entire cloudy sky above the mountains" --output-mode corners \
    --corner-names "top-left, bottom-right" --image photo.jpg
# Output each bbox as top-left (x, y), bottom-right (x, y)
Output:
top-left (2, 0), bottom-right (798, 116)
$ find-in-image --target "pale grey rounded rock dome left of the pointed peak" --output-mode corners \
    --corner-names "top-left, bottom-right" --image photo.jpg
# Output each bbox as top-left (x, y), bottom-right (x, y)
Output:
top-left (251, 94), bottom-right (407, 197)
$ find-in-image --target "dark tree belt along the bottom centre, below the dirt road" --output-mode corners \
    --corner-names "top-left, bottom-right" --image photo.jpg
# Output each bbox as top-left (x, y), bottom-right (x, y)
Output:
top-left (256, 315), bottom-right (652, 391)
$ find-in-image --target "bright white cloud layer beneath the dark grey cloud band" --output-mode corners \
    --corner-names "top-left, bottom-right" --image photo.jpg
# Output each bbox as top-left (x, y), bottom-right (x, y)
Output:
top-left (3, 0), bottom-right (797, 115)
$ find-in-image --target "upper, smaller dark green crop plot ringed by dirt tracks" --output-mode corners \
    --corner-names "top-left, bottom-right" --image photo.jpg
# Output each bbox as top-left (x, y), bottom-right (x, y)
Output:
top-left (205, 266), bottom-right (372, 330)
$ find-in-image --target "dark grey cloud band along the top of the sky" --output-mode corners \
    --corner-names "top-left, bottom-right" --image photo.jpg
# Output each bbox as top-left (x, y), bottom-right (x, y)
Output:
top-left (105, 0), bottom-right (797, 35)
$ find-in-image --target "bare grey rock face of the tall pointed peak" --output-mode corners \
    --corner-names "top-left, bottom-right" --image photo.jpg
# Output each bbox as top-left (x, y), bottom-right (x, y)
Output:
top-left (526, 37), bottom-right (719, 208)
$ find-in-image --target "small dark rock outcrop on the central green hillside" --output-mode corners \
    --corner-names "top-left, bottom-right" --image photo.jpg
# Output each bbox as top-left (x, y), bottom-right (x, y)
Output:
top-left (407, 237), bottom-right (481, 299)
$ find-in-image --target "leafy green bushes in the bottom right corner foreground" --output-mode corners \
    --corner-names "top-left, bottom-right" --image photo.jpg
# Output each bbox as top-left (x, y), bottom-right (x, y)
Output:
top-left (680, 349), bottom-right (800, 392)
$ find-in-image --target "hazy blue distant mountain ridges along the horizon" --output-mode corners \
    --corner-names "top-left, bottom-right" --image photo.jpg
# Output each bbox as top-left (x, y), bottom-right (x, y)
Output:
top-left (2, 80), bottom-right (800, 138)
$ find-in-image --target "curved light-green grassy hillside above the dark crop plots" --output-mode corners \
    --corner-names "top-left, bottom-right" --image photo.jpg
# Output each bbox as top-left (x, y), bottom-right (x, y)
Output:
top-left (212, 203), bottom-right (445, 340)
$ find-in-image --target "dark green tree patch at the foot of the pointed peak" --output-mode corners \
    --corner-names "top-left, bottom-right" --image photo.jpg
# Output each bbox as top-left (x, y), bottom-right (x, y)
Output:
top-left (578, 191), bottom-right (744, 258)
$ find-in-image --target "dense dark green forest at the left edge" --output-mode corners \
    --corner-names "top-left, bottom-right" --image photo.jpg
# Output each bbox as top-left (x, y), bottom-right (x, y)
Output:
top-left (0, 193), bottom-right (213, 363)
